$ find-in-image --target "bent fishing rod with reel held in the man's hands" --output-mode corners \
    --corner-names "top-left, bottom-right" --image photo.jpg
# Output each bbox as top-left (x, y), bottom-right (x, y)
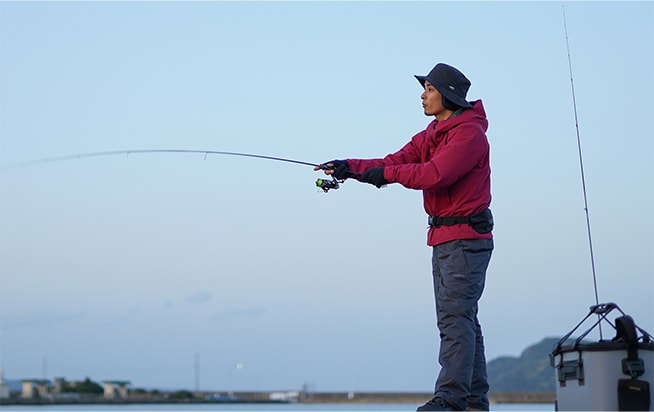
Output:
top-left (5, 149), bottom-right (344, 193)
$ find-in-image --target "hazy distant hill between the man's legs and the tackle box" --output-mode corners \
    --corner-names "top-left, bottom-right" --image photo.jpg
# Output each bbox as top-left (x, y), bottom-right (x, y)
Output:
top-left (487, 338), bottom-right (559, 392)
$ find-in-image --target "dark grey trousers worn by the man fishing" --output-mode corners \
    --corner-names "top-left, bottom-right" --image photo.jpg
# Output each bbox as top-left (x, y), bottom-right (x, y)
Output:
top-left (432, 239), bottom-right (493, 410)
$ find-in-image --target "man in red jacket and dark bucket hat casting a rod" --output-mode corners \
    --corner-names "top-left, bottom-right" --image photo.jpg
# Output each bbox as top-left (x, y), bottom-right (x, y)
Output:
top-left (314, 63), bottom-right (493, 411)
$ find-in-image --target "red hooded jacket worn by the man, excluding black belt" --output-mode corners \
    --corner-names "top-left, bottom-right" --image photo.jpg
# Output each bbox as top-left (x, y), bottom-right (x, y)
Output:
top-left (347, 100), bottom-right (493, 246)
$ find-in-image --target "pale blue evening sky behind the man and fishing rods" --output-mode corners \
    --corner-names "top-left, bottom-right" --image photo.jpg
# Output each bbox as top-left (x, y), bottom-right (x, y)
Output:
top-left (0, 2), bottom-right (654, 392)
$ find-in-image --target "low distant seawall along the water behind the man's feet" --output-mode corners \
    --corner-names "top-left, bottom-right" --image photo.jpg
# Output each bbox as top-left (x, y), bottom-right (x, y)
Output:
top-left (0, 392), bottom-right (556, 406)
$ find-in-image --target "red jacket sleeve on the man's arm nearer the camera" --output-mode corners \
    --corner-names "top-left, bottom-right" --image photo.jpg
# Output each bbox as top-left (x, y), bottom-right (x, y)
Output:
top-left (384, 125), bottom-right (489, 190)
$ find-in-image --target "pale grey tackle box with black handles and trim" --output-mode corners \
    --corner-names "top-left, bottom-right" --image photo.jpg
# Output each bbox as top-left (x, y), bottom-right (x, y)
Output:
top-left (550, 303), bottom-right (654, 411)
